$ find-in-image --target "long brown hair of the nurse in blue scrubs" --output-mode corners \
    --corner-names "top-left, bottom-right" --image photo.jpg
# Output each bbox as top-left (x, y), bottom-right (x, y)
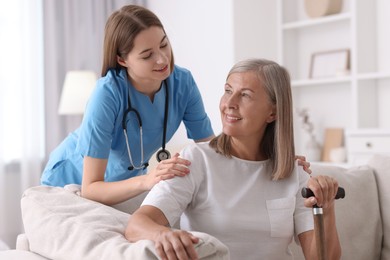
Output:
top-left (101, 5), bottom-right (175, 76)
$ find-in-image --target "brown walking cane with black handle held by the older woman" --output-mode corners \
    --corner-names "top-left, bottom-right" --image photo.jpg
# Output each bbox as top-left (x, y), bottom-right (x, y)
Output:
top-left (302, 187), bottom-right (345, 260)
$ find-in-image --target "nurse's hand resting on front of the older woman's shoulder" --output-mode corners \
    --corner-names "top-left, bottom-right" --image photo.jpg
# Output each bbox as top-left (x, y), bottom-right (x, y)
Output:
top-left (145, 153), bottom-right (191, 190)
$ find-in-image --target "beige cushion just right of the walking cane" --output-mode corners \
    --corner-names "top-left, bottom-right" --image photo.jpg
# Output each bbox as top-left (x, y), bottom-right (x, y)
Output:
top-left (291, 165), bottom-right (382, 260)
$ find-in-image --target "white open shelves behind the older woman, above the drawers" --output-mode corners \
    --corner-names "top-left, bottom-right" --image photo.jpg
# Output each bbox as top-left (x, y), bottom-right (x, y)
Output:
top-left (277, 0), bottom-right (390, 160)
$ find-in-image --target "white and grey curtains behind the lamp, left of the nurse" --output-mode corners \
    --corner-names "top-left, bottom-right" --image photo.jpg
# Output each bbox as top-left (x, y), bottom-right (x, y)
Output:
top-left (0, 0), bottom-right (145, 248)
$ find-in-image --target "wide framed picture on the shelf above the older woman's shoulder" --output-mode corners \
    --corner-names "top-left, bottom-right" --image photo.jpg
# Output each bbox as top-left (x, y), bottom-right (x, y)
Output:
top-left (309, 49), bottom-right (350, 79)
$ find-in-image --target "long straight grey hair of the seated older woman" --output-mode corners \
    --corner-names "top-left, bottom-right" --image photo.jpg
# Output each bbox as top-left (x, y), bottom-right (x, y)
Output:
top-left (210, 59), bottom-right (295, 180)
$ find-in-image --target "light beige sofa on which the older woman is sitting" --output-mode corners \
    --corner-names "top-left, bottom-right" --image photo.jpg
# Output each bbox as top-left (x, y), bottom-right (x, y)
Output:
top-left (0, 155), bottom-right (390, 260)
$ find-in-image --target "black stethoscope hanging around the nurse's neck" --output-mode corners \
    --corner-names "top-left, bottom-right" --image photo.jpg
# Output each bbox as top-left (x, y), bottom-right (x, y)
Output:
top-left (114, 69), bottom-right (171, 171)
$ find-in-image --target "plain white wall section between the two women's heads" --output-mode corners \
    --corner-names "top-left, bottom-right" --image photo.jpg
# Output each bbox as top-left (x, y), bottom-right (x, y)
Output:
top-left (148, 0), bottom-right (234, 145)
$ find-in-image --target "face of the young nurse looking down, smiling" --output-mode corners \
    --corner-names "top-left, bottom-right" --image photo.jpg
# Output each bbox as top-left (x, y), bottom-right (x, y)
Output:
top-left (118, 26), bottom-right (172, 90)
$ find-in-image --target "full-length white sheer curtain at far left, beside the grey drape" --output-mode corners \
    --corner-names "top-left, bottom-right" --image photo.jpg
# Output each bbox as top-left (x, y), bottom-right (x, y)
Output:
top-left (0, 0), bottom-right (44, 247)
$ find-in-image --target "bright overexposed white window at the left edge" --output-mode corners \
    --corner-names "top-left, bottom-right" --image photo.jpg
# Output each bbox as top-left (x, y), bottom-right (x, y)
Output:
top-left (0, 0), bottom-right (44, 163)
